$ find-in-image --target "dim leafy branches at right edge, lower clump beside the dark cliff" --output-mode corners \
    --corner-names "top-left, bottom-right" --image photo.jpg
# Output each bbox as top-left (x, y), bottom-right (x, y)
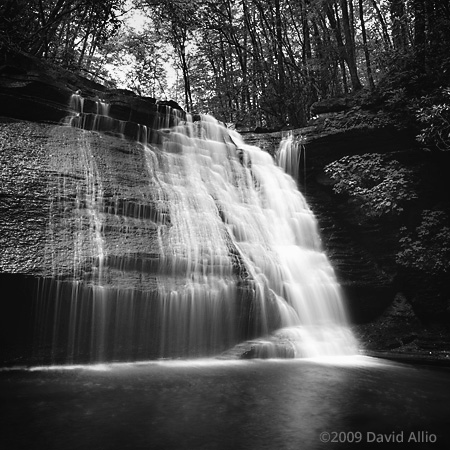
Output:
top-left (397, 210), bottom-right (450, 275)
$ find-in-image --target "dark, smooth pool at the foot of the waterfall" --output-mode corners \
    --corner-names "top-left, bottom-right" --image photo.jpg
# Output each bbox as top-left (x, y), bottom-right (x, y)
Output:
top-left (0, 357), bottom-right (450, 450)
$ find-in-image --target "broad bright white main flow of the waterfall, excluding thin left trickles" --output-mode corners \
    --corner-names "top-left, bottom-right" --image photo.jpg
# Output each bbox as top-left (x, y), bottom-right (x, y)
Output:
top-left (139, 113), bottom-right (356, 357)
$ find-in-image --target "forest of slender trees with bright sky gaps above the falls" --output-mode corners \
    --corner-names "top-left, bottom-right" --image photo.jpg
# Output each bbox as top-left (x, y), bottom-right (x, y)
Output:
top-left (0, 0), bottom-right (450, 142)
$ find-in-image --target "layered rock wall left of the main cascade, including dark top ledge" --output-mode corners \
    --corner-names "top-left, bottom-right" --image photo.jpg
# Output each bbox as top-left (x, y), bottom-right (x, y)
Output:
top-left (0, 54), bottom-right (206, 364)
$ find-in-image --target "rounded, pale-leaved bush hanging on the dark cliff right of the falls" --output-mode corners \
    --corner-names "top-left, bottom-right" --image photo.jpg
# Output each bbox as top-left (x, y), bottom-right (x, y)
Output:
top-left (325, 153), bottom-right (417, 217)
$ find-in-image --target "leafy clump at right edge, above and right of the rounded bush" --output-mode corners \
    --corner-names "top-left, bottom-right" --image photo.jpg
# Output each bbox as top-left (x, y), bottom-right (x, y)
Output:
top-left (417, 88), bottom-right (450, 150)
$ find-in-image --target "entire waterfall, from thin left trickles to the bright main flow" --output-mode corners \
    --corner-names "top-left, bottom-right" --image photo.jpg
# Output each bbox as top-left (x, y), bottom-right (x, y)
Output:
top-left (33, 94), bottom-right (356, 362)
